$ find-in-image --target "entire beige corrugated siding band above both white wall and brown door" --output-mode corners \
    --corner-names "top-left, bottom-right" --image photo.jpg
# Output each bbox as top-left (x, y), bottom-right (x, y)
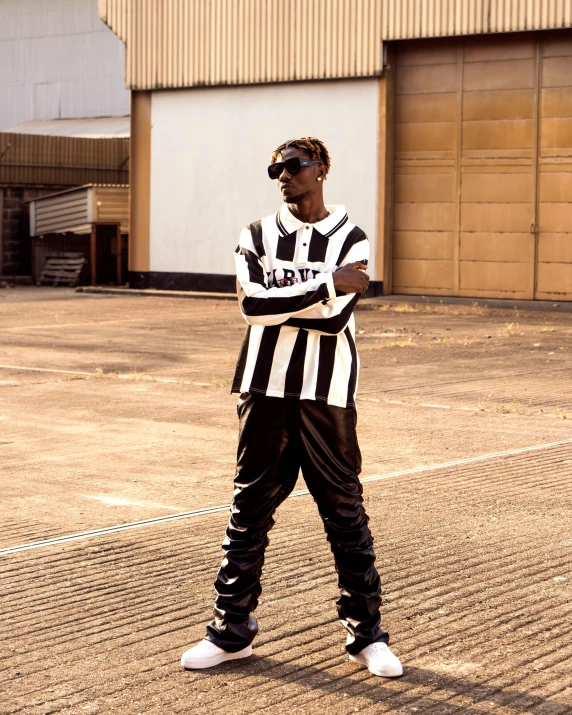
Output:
top-left (98, 0), bottom-right (572, 89)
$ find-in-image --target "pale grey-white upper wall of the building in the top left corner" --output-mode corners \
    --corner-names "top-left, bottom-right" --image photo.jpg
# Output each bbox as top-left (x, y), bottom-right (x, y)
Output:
top-left (0, 0), bottom-right (130, 131)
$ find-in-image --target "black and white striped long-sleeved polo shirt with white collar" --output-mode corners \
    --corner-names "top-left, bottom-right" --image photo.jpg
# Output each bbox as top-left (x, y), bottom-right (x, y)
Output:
top-left (232, 204), bottom-right (369, 407)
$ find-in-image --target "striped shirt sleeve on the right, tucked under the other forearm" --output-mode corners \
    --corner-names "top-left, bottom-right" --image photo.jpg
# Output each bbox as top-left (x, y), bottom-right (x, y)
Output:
top-left (286, 226), bottom-right (369, 335)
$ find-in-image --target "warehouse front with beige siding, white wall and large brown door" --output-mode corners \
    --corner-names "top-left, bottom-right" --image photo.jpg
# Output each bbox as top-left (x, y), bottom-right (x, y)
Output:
top-left (99, 0), bottom-right (572, 300)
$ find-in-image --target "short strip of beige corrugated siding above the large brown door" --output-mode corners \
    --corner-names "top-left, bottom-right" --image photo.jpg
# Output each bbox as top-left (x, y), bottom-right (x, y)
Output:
top-left (381, 0), bottom-right (572, 40)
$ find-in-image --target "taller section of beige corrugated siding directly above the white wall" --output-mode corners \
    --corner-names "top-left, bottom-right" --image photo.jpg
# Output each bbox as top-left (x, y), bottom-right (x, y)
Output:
top-left (99, 0), bottom-right (383, 89)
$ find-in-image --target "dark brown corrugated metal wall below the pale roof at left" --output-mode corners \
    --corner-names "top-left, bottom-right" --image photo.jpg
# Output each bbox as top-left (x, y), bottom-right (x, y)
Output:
top-left (0, 133), bottom-right (129, 186)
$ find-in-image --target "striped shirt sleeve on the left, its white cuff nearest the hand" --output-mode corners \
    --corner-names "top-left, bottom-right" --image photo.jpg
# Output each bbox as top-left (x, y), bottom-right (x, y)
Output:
top-left (234, 228), bottom-right (336, 325)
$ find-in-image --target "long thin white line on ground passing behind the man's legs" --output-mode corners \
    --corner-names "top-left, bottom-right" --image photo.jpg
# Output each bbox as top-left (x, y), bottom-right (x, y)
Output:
top-left (0, 439), bottom-right (572, 556)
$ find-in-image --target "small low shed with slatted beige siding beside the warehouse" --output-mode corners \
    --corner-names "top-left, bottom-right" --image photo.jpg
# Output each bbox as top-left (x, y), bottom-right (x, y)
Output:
top-left (30, 184), bottom-right (129, 285)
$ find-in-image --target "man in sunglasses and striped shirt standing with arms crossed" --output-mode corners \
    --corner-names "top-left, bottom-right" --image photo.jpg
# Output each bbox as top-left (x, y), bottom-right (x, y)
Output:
top-left (181, 137), bottom-right (403, 677)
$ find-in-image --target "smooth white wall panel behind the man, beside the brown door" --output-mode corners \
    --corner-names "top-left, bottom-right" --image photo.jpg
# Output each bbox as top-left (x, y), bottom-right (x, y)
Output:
top-left (151, 79), bottom-right (379, 278)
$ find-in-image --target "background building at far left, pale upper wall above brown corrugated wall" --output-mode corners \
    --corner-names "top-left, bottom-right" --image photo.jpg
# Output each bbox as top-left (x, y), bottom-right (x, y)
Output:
top-left (0, 0), bottom-right (130, 279)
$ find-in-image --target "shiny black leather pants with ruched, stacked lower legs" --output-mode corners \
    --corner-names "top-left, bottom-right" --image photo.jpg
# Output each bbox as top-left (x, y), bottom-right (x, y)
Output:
top-left (202, 393), bottom-right (389, 654)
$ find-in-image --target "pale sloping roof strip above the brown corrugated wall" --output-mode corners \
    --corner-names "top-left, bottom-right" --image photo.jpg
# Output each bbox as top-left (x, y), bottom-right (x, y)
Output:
top-left (6, 117), bottom-right (130, 139)
